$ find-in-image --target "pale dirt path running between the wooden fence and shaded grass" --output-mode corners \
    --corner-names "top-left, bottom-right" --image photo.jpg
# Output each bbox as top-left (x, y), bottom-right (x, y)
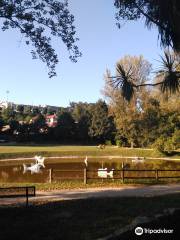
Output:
top-left (0, 184), bottom-right (180, 206)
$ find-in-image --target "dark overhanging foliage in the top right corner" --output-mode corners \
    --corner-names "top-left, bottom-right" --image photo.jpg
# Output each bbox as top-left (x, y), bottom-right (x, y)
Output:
top-left (114, 0), bottom-right (180, 53)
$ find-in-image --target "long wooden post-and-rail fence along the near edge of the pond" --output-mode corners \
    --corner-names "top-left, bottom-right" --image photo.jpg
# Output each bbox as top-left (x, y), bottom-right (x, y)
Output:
top-left (49, 168), bottom-right (180, 184)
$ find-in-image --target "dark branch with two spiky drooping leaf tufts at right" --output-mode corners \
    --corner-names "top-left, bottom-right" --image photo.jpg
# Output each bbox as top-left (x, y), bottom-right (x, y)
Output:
top-left (106, 51), bottom-right (180, 101)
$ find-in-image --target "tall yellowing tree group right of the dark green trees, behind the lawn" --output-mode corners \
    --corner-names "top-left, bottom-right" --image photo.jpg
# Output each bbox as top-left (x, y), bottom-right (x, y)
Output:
top-left (103, 55), bottom-right (180, 153)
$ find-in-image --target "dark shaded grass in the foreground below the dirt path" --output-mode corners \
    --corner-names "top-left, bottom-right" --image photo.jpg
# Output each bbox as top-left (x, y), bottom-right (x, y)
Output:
top-left (0, 194), bottom-right (180, 240)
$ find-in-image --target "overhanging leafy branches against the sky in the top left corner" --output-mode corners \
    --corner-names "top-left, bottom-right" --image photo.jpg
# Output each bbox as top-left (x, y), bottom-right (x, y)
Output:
top-left (0, 0), bottom-right (81, 77)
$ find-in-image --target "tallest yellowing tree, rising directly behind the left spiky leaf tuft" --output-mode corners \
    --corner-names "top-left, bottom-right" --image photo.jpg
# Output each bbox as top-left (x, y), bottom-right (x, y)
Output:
top-left (103, 56), bottom-right (161, 146)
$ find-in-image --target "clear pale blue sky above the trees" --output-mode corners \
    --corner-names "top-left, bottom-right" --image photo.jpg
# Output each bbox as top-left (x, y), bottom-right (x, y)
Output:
top-left (0, 0), bottom-right (162, 106)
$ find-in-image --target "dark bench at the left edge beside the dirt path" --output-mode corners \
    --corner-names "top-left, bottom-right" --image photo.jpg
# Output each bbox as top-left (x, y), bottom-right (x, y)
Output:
top-left (0, 186), bottom-right (36, 207)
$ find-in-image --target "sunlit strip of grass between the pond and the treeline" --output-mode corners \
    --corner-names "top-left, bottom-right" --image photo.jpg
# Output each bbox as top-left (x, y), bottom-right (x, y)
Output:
top-left (0, 145), bottom-right (179, 159)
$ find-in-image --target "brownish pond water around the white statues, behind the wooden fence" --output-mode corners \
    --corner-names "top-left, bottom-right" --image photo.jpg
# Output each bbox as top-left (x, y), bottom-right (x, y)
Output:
top-left (0, 158), bottom-right (180, 183)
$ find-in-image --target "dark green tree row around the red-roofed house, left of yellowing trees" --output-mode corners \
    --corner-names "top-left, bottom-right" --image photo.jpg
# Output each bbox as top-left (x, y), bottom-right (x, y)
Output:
top-left (0, 100), bottom-right (115, 144)
